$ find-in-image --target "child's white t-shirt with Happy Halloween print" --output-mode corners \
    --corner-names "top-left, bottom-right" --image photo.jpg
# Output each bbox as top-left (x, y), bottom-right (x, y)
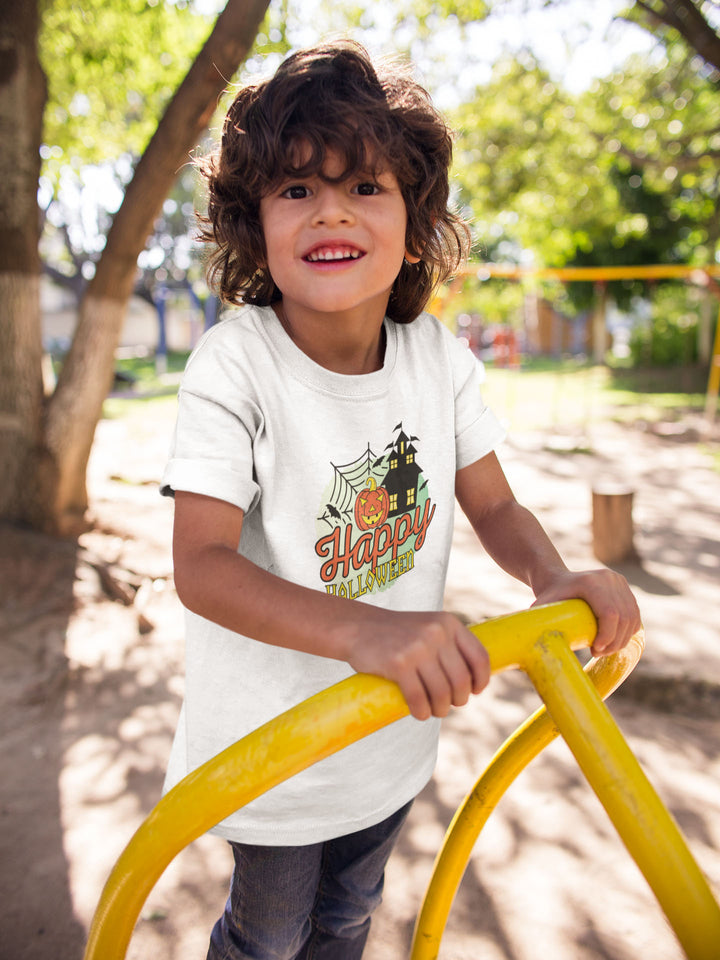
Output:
top-left (162, 306), bottom-right (503, 845)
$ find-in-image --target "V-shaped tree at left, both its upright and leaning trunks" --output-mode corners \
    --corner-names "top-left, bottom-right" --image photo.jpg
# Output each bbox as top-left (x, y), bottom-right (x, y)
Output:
top-left (0, 0), bottom-right (268, 534)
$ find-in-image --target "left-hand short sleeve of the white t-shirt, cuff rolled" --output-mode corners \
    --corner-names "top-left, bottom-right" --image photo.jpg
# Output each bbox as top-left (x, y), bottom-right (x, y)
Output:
top-left (160, 328), bottom-right (263, 513)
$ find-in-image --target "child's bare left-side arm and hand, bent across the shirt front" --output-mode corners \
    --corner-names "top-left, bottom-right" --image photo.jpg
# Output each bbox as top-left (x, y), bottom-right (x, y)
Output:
top-left (173, 491), bottom-right (489, 720)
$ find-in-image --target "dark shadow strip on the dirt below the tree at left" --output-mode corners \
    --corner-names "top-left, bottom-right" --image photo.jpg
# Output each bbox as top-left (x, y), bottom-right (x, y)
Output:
top-left (0, 527), bottom-right (85, 960)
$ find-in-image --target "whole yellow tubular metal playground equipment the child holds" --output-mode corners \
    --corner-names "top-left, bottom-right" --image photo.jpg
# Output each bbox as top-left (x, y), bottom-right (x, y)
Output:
top-left (85, 600), bottom-right (720, 960)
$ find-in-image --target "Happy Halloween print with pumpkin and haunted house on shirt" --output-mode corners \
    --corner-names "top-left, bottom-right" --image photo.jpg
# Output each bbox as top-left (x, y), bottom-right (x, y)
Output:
top-left (315, 421), bottom-right (435, 599)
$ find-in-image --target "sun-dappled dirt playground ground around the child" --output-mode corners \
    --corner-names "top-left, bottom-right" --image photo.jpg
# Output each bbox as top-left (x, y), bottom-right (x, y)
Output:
top-left (0, 403), bottom-right (720, 960)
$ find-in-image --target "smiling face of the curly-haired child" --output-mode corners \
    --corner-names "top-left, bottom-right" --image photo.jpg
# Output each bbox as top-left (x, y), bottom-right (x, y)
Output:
top-left (260, 150), bottom-right (414, 319)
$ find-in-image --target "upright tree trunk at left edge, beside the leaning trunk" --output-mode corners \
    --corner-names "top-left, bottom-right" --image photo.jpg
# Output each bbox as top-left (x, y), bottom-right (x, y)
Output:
top-left (0, 0), bottom-right (46, 520)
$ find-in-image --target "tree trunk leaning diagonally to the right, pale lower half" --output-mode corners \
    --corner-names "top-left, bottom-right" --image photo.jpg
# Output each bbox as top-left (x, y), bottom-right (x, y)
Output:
top-left (29, 0), bottom-right (269, 536)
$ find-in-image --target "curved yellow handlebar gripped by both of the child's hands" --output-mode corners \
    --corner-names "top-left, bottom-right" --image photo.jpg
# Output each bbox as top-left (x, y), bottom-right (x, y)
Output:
top-left (85, 600), bottom-right (596, 960)
